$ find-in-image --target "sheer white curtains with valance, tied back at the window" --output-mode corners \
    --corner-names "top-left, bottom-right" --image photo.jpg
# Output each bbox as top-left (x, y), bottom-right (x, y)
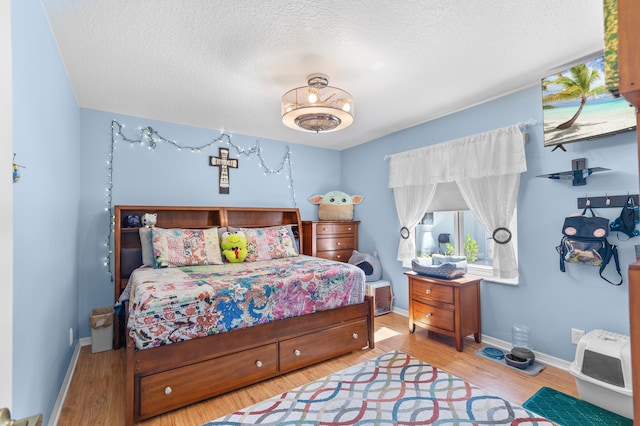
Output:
top-left (389, 125), bottom-right (527, 278)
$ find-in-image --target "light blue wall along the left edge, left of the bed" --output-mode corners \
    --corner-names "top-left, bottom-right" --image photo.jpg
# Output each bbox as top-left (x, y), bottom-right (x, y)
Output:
top-left (9, 0), bottom-right (80, 424)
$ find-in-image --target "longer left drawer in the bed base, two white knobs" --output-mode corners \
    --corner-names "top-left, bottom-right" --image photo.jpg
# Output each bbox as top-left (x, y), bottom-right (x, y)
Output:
top-left (139, 342), bottom-right (276, 417)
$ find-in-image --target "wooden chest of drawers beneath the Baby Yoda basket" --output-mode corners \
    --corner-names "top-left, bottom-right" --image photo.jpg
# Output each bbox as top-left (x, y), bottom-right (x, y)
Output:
top-left (302, 220), bottom-right (360, 262)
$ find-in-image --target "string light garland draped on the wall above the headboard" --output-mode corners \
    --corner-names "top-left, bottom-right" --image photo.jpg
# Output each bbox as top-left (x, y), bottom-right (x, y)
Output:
top-left (104, 120), bottom-right (297, 280)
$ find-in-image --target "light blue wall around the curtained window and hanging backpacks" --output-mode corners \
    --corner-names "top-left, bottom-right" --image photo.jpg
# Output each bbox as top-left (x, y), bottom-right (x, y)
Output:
top-left (342, 85), bottom-right (640, 360)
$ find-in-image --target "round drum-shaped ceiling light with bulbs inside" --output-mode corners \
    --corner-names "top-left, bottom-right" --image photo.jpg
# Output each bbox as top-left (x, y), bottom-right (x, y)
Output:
top-left (282, 73), bottom-right (353, 133)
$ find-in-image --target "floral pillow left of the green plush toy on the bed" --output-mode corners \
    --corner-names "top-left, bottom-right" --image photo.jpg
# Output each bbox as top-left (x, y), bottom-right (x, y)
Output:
top-left (151, 228), bottom-right (222, 268)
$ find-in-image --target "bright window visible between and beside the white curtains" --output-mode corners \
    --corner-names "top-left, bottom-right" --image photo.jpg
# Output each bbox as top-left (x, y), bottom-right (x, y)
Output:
top-left (415, 210), bottom-right (518, 284)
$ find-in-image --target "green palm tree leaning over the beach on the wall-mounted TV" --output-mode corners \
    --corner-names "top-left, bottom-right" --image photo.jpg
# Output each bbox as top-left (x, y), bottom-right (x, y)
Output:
top-left (542, 64), bottom-right (606, 130)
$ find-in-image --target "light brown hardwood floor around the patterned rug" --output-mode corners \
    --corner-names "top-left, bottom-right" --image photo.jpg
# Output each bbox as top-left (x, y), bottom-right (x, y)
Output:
top-left (58, 313), bottom-right (578, 426)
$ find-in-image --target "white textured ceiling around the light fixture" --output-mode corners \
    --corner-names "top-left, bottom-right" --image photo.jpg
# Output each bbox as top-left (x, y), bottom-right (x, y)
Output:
top-left (43, 0), bottom-right (603, 150)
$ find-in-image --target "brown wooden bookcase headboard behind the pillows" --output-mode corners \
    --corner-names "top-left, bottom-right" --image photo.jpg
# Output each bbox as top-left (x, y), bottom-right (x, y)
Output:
top-left (113, 206), bottom-right (302, 301)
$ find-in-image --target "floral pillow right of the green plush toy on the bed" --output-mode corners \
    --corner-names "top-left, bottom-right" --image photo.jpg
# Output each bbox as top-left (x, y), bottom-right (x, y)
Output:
top-left (229, 226), bottom-right (298, 262)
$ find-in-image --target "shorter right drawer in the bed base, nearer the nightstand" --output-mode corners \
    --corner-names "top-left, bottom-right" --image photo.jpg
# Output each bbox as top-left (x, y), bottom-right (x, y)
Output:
top-left (278, 318), bottom-right (369, 372)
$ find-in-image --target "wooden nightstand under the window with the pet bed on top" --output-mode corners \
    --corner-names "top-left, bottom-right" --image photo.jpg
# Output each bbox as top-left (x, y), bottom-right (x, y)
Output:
top-left (405, 272), bottom-right (482, 352)
